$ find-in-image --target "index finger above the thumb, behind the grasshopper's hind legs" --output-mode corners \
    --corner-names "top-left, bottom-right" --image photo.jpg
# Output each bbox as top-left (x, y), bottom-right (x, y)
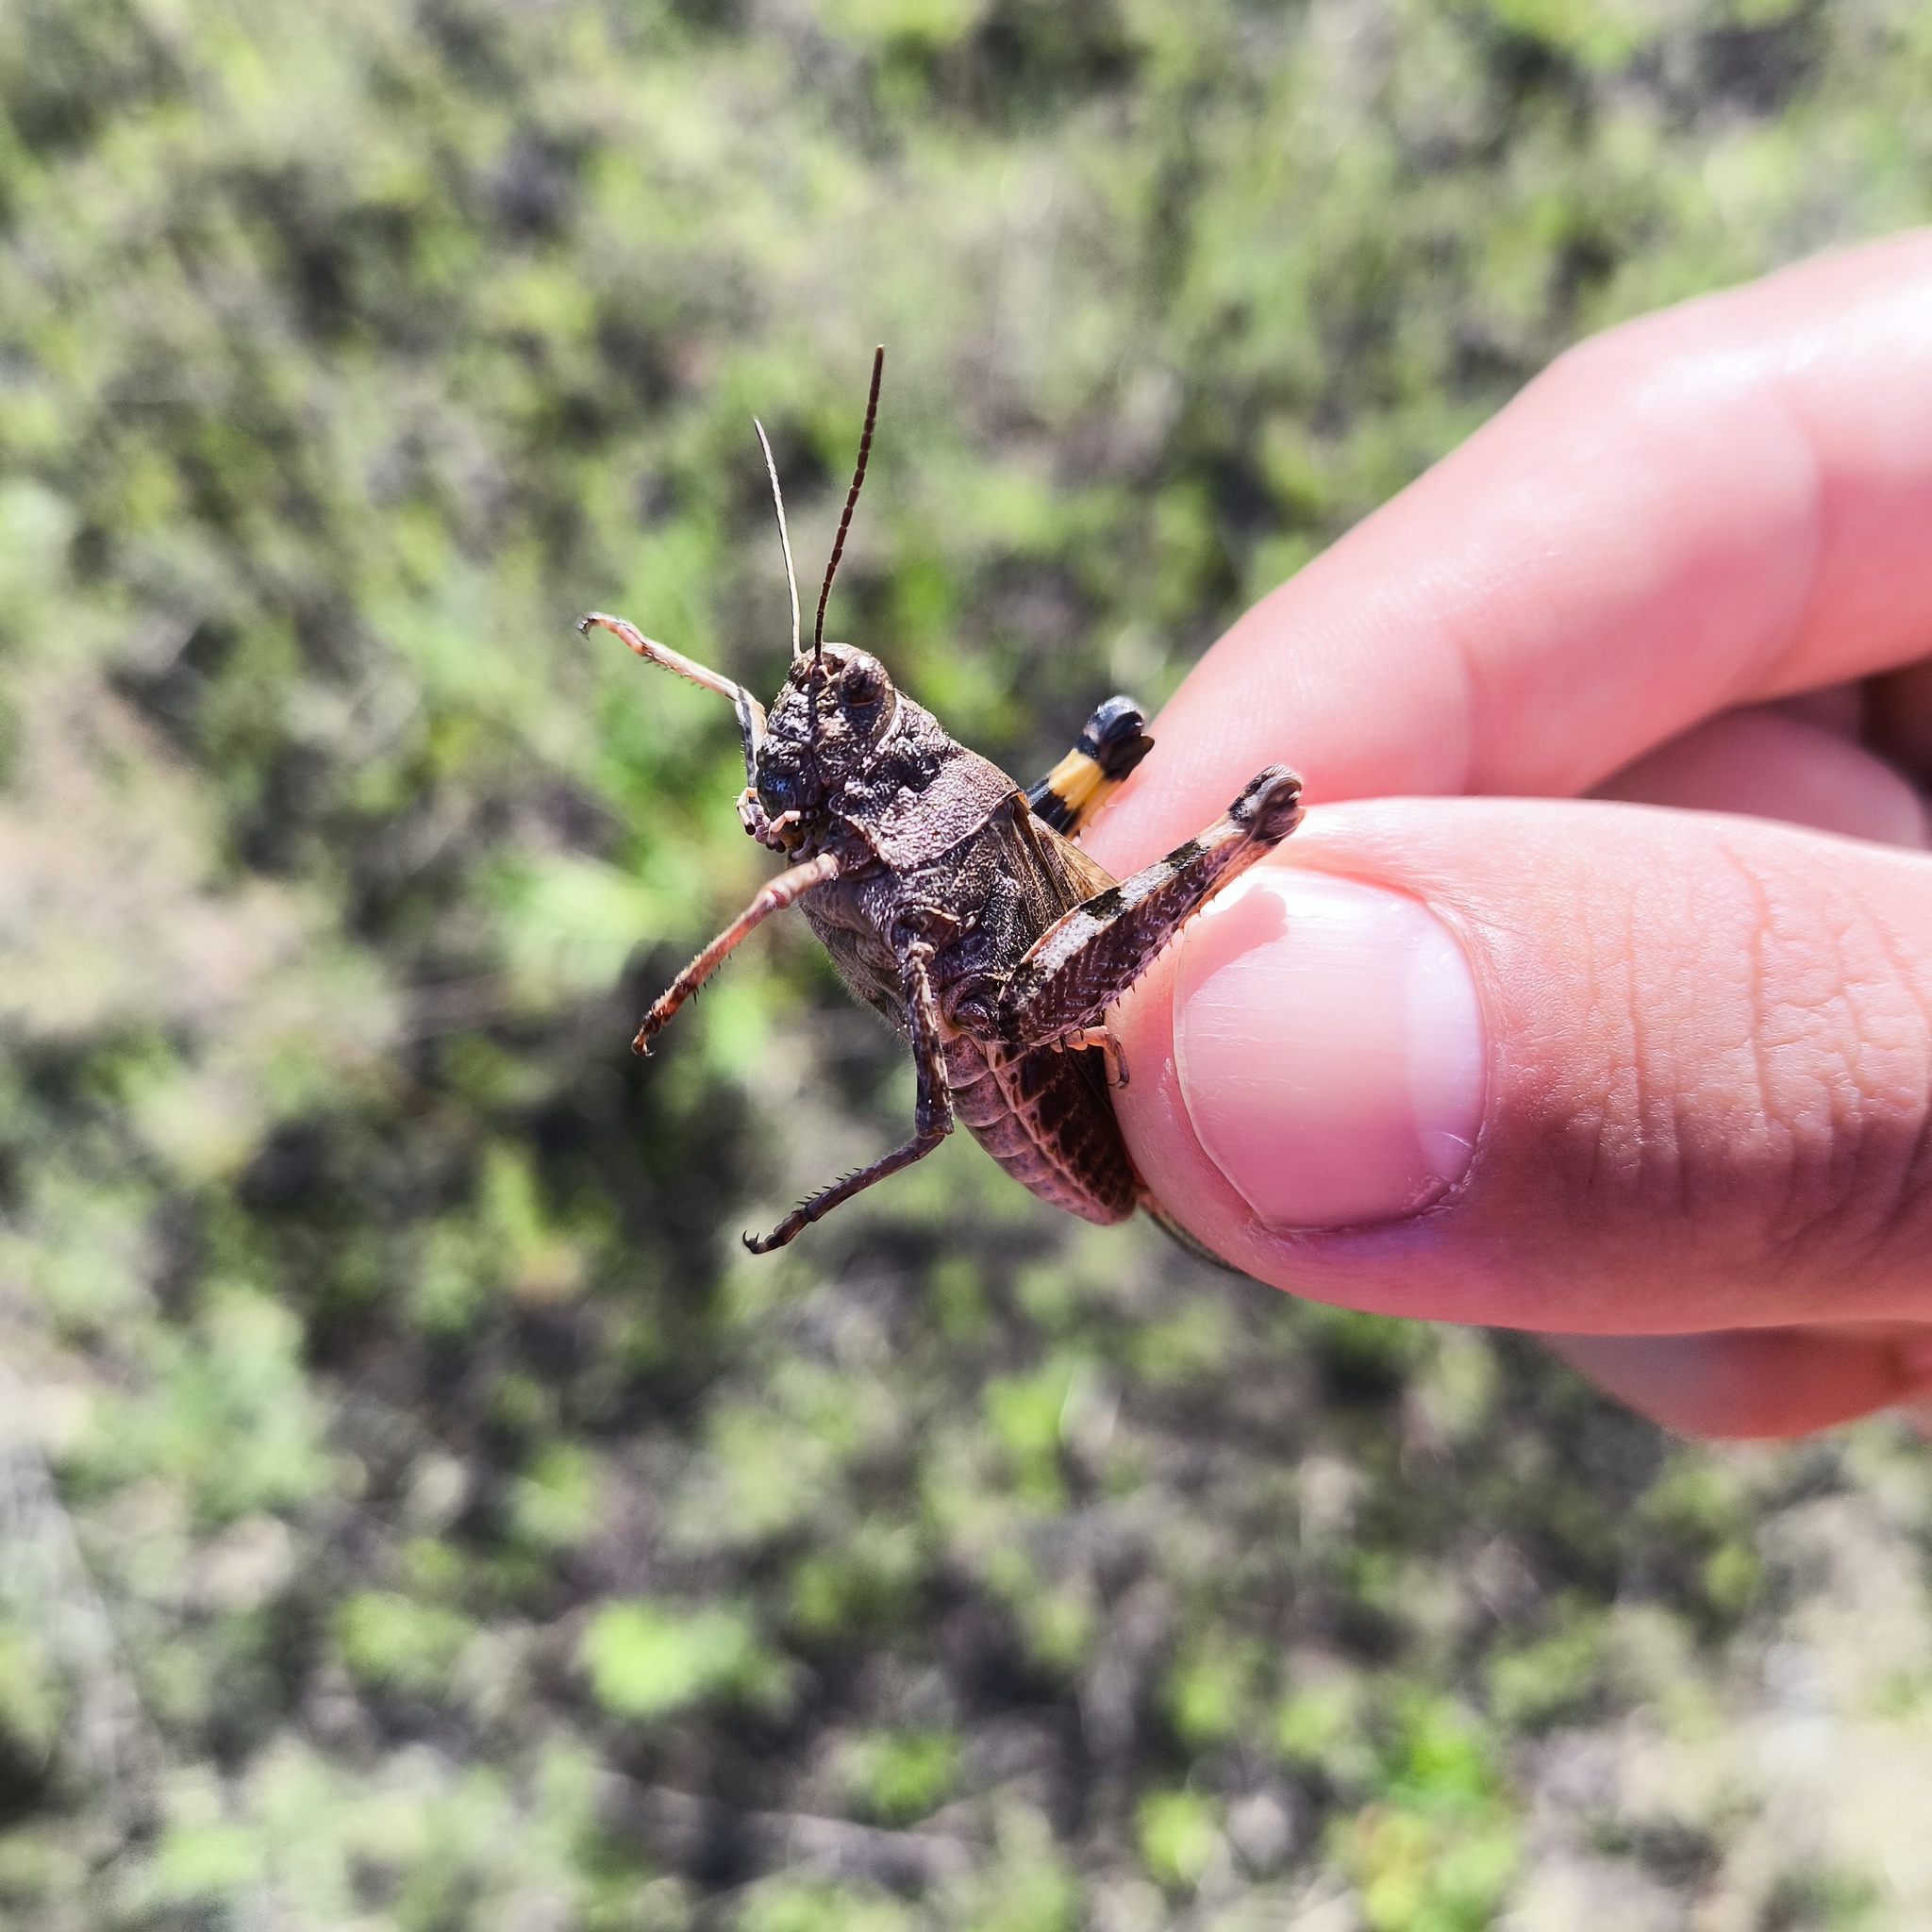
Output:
top-left (1088, 232), bottom-right (1932, 874)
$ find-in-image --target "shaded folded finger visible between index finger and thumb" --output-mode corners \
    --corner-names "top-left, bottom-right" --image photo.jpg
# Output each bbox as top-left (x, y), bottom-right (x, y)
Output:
top-left (1594, 709), bottom-right (1926, 846)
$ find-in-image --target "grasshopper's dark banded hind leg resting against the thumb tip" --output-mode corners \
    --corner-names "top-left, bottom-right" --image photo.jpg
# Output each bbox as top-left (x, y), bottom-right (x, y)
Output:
top-left (997, 765), bottom-right (1302, 1047)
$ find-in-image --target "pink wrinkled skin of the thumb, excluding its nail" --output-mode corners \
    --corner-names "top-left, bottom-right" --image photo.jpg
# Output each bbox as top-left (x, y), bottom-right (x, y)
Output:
top-left (1113, 800), bottom-right (1932, 1335)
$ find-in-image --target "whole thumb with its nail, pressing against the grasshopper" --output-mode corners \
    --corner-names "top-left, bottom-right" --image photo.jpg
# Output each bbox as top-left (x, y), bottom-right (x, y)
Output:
top-left (1115, 798), bottom-right (1932, 1337)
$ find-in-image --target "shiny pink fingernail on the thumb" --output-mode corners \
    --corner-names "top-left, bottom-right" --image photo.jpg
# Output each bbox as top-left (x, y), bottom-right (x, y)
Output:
top-left (1174, 866), bottom-right (1486, 1229)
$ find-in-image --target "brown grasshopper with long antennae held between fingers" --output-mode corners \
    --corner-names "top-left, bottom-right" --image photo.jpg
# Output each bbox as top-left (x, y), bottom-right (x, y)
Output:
top-left (577, 348), bottom-right (1302, 1254)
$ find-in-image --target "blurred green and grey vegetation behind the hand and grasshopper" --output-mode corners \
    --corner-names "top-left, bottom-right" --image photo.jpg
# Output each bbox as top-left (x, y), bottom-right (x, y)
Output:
top-left (11, 0), bottom-right (1932, 1932)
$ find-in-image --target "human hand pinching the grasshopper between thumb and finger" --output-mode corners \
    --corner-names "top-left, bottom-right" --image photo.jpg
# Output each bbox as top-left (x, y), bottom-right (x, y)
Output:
top-left (1086, 230), bottom-right (1932, 1436)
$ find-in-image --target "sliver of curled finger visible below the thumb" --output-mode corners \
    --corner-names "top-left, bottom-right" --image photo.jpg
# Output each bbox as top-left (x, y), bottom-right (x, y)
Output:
top-left (1543, 1329), bottom-right (1932, 1440)
